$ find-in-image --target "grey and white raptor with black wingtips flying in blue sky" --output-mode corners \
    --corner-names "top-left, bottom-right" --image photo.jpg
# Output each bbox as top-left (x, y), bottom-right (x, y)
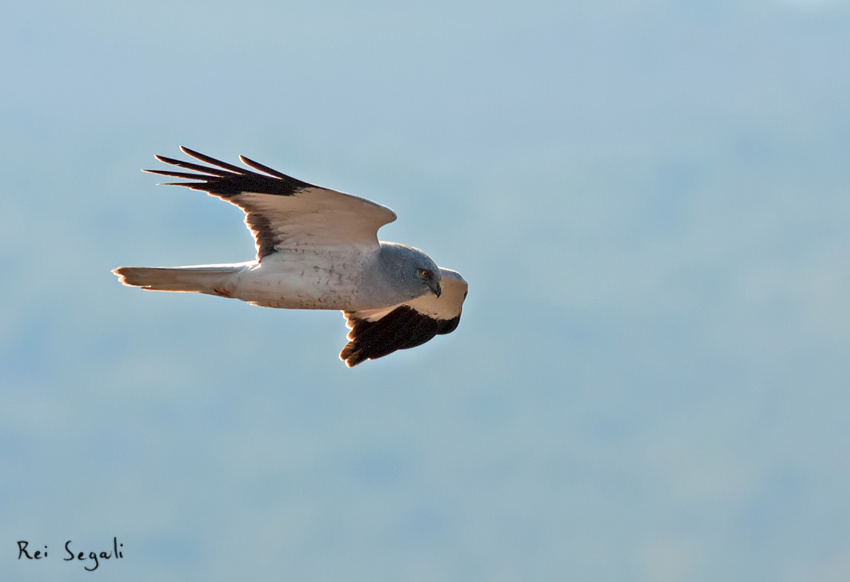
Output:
top-left (112, 146), bottom-right (468, 368)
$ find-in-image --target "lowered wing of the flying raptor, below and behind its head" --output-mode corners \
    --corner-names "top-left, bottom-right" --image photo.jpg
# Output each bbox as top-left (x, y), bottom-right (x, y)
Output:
top-left (339, 268), bottom-right (467, 368)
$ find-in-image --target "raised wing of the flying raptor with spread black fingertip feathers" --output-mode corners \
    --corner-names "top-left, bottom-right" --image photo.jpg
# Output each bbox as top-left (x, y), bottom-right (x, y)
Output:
top-left (144, 146), bottom-right (396, 260)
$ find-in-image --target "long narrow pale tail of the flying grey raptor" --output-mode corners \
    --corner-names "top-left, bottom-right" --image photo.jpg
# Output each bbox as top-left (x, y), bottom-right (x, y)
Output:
top-left (112, 264), bottom-right (245, 296)
